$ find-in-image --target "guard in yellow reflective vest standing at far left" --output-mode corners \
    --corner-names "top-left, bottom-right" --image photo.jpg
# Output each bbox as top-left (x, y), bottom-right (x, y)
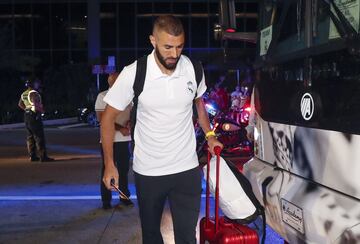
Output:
top-left (18, 79), bottom-right (54, 162)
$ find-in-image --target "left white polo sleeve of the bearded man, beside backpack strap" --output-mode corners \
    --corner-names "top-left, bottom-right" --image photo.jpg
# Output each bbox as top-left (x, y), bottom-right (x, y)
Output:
top-left (104, 61), bottom-right (136, 111)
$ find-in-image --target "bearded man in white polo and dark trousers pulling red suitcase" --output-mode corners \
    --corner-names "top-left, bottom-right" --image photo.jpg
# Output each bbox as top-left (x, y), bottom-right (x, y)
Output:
top-left (101, 15), bottom-right (222, 244)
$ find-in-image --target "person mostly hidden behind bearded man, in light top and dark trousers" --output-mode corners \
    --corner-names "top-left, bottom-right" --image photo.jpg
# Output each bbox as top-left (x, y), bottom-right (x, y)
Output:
top-left (95, 72), bottom-right (133, 209)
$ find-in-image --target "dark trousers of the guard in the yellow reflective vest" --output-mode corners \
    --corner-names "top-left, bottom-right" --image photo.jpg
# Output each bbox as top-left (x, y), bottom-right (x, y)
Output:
top-left (24, 111), bottom-right (47, 158)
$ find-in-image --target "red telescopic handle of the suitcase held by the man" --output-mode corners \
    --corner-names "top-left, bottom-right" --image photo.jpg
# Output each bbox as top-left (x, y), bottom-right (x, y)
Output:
top-left (205, 146), bottom-right (221, 233)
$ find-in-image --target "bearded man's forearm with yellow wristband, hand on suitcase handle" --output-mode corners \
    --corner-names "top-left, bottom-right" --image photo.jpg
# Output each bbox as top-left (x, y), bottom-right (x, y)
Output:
top-left (195, 97), bottom-right (223, 155)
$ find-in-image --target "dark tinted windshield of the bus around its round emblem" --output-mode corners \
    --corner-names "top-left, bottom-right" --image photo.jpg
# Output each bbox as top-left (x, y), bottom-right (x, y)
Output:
top-left (257, 1), bottom-right (360, 134)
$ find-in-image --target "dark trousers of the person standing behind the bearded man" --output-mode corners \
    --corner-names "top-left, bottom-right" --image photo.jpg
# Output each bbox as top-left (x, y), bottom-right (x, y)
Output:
top-left (100, 141), bottom-right (130, 203)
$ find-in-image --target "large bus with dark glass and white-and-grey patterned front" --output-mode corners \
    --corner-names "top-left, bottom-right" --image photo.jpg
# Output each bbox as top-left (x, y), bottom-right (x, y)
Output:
top-left (244, 0), bottom-right (360, 244)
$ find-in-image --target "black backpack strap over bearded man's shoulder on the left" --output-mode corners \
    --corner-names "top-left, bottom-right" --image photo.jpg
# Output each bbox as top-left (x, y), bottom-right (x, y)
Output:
top-left (130, 55), bottom-right (147, 147)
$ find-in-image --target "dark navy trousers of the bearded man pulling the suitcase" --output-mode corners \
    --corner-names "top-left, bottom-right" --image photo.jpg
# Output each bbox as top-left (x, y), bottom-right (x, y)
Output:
top-left (135, 168), bottom-right (201, 244)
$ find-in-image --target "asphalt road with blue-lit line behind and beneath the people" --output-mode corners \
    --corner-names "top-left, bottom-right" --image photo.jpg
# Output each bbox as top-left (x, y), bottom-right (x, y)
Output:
top-left (0, 127), bottom-right (282, 244)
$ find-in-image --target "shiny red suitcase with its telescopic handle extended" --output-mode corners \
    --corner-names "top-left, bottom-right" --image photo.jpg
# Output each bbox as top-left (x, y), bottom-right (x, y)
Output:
top-left (200, 148), bottom-right (259, 244)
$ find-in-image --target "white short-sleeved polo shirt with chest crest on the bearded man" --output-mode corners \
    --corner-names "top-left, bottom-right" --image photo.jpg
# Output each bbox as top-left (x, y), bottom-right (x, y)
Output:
top-left (104, 51), bottom-right (206, 176)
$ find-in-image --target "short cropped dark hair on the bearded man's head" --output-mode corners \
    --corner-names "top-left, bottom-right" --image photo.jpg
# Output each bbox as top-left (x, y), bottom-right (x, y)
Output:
top-left (153, 15), bottom-right (184, 36)
